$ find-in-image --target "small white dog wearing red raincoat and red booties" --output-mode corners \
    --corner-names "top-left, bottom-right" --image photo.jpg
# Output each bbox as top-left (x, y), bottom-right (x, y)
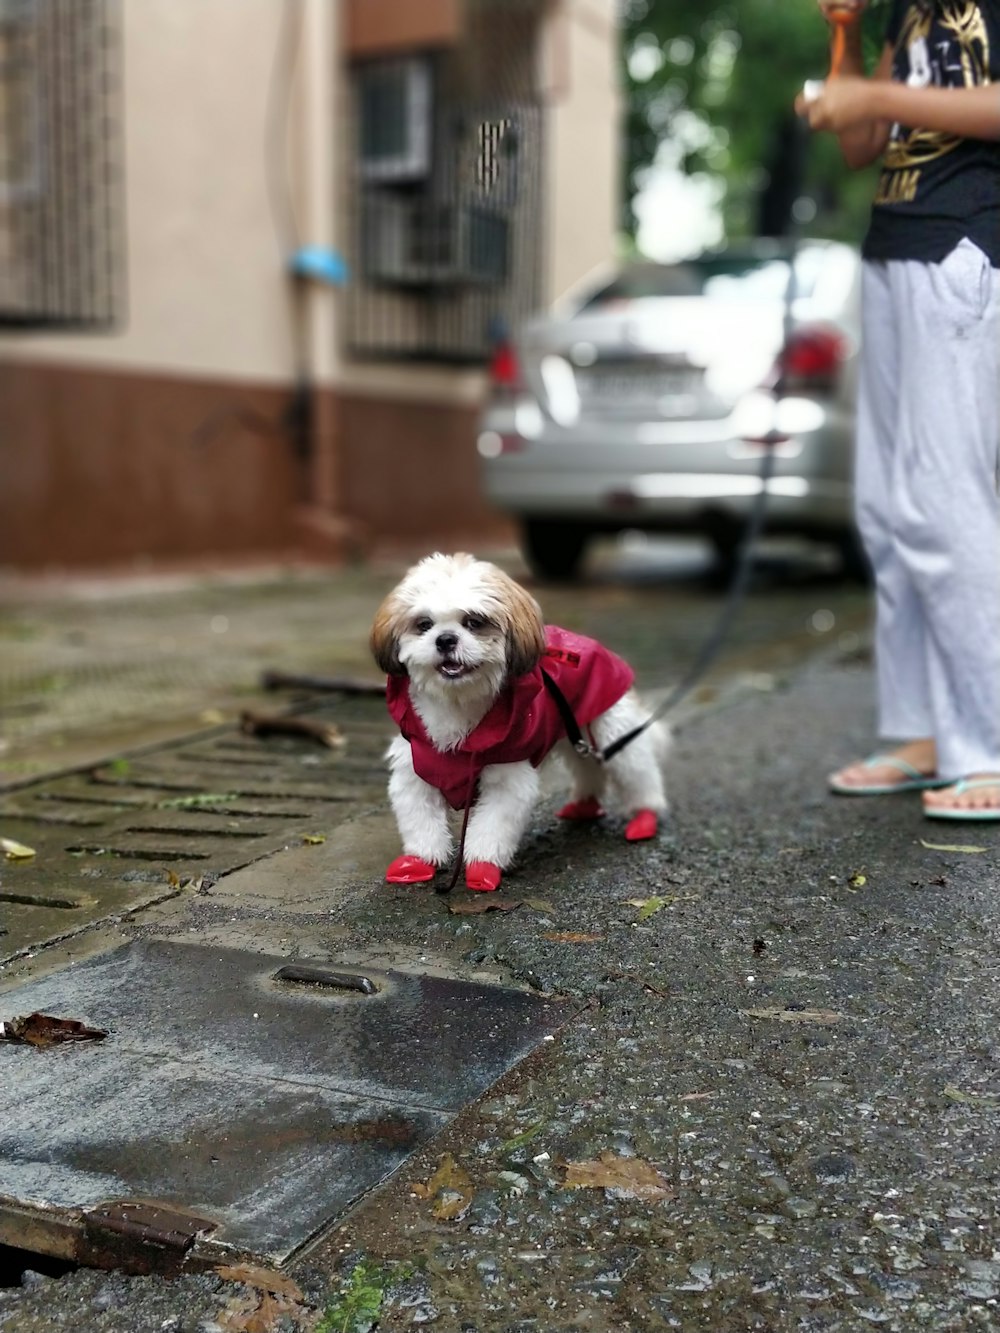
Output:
top-left (371, 553), bottom-right (667, 890)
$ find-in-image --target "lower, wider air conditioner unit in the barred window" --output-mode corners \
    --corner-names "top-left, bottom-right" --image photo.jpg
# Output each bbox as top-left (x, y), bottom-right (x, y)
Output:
top-left (363, 191), bottom-right (509, 287)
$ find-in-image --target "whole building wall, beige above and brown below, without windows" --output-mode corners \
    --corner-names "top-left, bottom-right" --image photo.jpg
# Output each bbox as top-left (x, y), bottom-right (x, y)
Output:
top-left (0, 0), bottom-right (619, 568)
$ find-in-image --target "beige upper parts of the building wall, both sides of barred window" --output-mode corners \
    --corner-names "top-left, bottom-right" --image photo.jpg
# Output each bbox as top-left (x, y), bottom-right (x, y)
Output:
top-left (0, 0), bottom-right (620, 389)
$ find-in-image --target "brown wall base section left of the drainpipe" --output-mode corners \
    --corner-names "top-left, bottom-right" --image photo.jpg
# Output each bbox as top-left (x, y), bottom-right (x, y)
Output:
top-left (0, 363), bottom-right (309, 568)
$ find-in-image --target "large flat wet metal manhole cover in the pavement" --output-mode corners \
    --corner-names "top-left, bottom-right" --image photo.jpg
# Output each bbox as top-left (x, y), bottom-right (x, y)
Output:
top-left (0, 941), bottom-right (568, 1268)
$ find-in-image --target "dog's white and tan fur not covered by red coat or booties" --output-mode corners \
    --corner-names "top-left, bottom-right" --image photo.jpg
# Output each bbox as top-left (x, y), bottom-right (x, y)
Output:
top-left (372, 555), bottom-right (667, 869)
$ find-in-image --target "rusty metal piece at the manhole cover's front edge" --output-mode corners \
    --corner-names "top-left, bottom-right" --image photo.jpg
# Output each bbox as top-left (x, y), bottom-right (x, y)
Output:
top-left (77, 1200), bottom-right (217, 1273)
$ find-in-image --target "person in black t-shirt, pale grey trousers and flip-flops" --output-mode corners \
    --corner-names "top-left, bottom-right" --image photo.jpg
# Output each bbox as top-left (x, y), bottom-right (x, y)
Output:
top-left (796, 0), bottom-right (1000, 820)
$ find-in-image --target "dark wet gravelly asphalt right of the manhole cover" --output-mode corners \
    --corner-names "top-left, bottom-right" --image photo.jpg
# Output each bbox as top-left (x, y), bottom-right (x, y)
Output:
top-left (0, 546), bottom-right (1000, 1333)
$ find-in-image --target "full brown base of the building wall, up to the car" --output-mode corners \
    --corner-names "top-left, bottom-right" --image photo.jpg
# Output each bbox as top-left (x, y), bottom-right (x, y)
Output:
top-left (0, 361), bottom-right (511, 569)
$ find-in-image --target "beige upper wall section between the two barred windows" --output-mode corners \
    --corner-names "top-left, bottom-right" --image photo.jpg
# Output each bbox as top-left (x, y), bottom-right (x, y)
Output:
top-left (0, 0), bottom-right (340, 383)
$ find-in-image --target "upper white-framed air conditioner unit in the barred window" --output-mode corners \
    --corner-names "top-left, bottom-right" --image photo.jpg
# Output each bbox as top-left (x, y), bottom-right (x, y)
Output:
top-left (357, 56), bottom-right (433, 184)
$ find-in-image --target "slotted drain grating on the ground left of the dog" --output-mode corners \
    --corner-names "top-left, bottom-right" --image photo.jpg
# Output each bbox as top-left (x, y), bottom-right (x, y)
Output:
top-left (0, 697), bottom-right (392, 961)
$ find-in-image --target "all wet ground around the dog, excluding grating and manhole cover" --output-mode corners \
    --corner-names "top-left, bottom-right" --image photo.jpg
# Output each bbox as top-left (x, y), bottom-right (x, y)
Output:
top-left (0, 543), bottom-right (1000, 1333)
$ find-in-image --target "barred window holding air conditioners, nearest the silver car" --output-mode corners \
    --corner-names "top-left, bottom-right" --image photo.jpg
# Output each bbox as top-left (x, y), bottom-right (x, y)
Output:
top-left (347, 0), bottom-right (545, 364)
